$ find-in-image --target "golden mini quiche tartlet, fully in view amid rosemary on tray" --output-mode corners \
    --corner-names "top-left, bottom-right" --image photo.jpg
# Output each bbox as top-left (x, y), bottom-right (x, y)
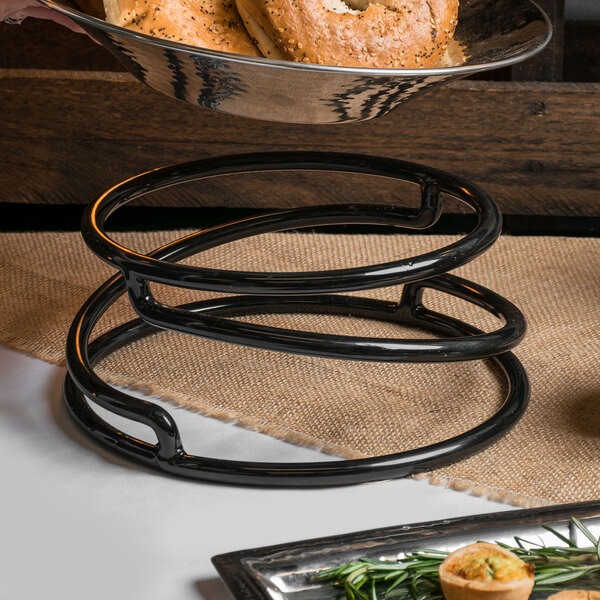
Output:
top-left (440, 542), bottom-right (535, 600)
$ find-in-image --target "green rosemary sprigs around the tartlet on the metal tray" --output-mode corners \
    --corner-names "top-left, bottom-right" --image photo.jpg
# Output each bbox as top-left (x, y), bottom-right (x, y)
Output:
top-left (314, 518), bottom-right (600, 600)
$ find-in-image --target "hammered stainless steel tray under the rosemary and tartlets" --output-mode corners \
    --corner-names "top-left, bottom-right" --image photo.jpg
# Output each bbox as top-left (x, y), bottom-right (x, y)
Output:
top-left (212, 502), bottom-right (600, 600)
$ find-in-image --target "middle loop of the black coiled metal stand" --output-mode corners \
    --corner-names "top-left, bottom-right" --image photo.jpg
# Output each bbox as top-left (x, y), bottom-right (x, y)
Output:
top-left (129, 275), bottom-right (526, 363)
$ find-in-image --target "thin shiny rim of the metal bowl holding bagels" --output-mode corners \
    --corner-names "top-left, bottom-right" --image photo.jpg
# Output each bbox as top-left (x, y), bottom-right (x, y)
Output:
top-left (37, 0), bottom-right (552, 78)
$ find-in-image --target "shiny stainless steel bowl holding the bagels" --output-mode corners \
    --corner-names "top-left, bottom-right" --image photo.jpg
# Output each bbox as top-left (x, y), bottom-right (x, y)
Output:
top-left (39, 0), bottom-right (552, 123)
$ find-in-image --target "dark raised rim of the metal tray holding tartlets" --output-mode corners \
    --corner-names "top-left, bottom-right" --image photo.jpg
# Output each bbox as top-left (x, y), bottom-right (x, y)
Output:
top-left (211, 500), bottom-right (600, 600)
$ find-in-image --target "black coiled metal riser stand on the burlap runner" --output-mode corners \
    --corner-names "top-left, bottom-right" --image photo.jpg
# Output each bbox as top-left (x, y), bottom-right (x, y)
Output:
top-left (64, 152), bottom-right (529, 486)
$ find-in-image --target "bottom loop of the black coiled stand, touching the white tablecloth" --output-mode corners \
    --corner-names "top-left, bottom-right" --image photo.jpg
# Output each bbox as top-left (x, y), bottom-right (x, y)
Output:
top-left (64, 270), bottom-right (529, 486)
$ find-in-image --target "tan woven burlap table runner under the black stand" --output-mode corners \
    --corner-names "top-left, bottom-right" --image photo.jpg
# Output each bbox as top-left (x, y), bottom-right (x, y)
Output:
top-left (0, 232), bottom-right (600, 506)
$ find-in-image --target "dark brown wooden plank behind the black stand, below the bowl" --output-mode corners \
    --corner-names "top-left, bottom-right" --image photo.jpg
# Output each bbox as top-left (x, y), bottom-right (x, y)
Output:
top-left (0, 70), bottom-right (600, 216)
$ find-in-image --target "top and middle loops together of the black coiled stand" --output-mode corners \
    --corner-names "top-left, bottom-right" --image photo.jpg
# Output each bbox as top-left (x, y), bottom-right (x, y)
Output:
top-left (83, 153), bottom-right (525, 362)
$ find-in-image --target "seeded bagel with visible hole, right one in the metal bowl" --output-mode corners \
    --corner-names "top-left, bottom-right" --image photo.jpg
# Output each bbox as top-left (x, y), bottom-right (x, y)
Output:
top-left (236, 0), bottom-right (458, 69)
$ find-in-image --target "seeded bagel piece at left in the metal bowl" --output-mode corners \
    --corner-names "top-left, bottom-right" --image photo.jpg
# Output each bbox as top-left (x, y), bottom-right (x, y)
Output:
top-left (104, 0), bottom-right (262, 56)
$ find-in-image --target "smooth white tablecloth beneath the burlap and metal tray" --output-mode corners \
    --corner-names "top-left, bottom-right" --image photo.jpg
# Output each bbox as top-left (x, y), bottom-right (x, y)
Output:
top-left (0, 347), bottom-right (510, 600)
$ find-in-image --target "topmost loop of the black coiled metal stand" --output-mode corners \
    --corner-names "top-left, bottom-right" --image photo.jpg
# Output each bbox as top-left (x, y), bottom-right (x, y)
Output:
top-left (82, 152), bottom-right (502, 295)
